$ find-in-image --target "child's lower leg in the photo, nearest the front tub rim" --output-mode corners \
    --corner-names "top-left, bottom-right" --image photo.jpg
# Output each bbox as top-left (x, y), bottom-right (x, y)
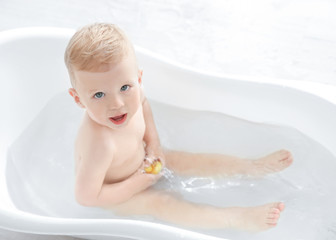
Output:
top-left (114, 190), bottom-right (284, 231)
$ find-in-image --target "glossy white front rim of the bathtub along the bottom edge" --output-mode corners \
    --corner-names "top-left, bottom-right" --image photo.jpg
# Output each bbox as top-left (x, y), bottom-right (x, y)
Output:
top-left (0, 206), bottom-right (228, 240)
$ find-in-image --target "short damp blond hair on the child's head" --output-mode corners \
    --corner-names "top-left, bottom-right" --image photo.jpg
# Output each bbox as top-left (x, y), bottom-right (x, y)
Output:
top-left (64, 23), bottom-right (134, 86)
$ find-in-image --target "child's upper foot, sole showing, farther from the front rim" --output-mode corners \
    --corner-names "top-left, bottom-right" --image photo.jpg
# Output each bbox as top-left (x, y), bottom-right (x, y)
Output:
top-left (249, 150), bottom-right (293, 176)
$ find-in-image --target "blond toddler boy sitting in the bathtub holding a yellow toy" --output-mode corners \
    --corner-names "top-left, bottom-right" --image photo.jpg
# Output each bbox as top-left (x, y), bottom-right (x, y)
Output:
top-left (65, 23), bottom-right (293, 231)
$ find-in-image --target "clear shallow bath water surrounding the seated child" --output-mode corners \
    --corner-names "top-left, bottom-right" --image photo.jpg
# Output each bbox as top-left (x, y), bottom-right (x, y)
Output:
top-left (6, 93), bottom-right (336, 240)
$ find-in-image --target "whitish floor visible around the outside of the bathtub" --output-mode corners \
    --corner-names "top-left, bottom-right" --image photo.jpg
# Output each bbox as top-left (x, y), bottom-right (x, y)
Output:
top-left (0, 0), bottom-right (336, 240)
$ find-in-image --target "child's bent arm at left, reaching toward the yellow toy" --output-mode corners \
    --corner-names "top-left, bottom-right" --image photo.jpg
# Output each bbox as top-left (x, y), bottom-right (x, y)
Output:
top-left (75, 142), bottom-right (159, 207)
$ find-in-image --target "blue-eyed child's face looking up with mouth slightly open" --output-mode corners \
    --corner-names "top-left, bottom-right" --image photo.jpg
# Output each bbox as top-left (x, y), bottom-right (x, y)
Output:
top-left (74, 56), bottom-right (141, 129)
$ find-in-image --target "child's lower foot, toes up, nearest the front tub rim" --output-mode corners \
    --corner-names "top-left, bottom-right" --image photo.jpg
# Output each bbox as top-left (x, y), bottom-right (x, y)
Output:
top-left (227, 202), bottom-right (285, 231)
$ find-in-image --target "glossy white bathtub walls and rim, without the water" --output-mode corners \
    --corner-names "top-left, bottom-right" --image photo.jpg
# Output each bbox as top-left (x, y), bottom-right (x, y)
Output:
top-left (0, 28), bottom-right (336, 240)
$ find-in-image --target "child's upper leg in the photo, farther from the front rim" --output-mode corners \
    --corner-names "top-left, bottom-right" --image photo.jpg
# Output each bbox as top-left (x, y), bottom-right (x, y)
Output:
top-left (165, 150), bottom-right (293, 177)
